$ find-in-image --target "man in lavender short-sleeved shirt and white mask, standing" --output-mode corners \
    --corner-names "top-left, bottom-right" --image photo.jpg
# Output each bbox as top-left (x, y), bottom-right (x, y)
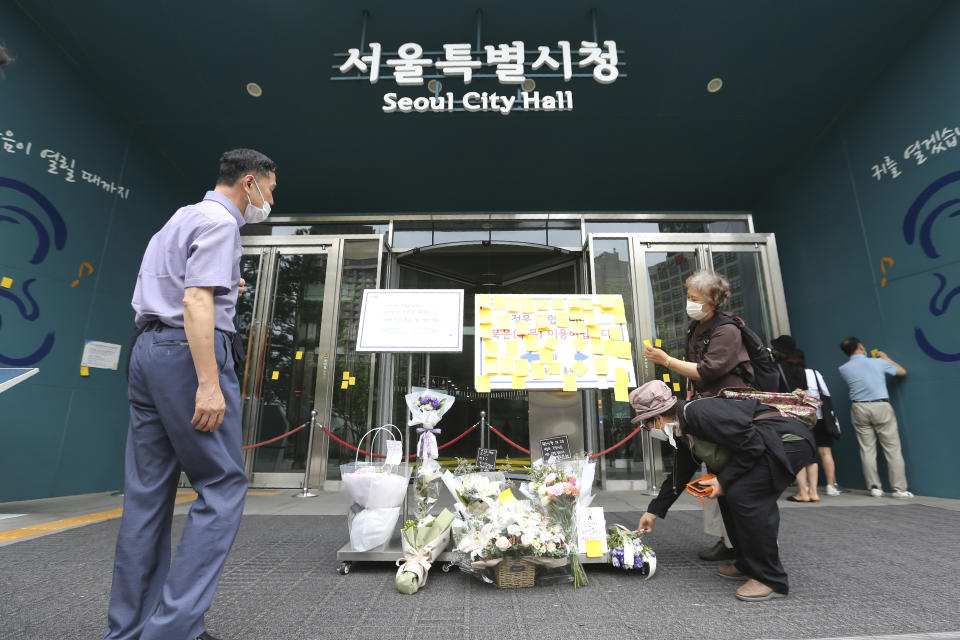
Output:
top-left (104, 149), bottom-right (277, 640)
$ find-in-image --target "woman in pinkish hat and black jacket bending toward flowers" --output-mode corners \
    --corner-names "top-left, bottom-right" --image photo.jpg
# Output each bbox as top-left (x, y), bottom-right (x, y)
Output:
top-left (630, 380), bottom-right (815, 601)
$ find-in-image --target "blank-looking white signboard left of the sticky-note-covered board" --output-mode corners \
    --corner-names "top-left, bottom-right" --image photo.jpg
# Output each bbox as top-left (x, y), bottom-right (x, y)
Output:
top-left (357, 289), bottom-right (463, 353)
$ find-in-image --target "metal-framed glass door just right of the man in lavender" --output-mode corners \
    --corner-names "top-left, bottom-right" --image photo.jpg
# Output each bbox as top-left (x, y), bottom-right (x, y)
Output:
top-left (237, 238), bottom-right (340, 487)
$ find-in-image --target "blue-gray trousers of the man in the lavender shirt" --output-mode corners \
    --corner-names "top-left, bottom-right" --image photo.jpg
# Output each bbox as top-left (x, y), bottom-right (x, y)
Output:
top-left (104, 326), bottom-right (247, 640)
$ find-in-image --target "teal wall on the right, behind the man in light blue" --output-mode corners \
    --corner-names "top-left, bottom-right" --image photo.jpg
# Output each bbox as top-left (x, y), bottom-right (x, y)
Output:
top-left (755, 3), bottom-right (960, 498)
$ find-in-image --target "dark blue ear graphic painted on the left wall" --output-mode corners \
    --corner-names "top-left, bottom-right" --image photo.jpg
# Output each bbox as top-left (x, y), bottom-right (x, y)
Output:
top-left (0, 177), bottom-right (67, 367)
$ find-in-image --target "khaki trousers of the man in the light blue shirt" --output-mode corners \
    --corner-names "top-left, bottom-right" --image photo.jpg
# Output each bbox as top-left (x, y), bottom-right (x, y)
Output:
top-left (850, 402), bottom-right (907, 491)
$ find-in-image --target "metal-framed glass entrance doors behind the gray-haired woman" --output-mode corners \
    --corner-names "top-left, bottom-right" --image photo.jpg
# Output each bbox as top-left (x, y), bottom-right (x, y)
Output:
top-left (590, 234), bottom-right (790, 491)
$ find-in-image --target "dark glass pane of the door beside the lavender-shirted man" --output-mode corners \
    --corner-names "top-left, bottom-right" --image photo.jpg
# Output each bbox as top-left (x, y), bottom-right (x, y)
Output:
top-left (253, 254), bottom-right (327, 472)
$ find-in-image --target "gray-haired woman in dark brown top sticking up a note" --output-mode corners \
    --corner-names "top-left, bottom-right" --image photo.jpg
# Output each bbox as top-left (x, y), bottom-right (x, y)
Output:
top-left (643, 270), bottom-right (753, 560)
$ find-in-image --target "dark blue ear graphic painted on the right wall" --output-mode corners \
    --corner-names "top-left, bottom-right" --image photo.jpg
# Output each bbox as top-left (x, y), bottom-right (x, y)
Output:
top-left (903, 171), bottom-right (960, 362)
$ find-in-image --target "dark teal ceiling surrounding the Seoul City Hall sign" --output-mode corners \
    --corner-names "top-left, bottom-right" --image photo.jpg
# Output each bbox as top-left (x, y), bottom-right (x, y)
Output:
top-left (15, 0), bottom-right (942, 215)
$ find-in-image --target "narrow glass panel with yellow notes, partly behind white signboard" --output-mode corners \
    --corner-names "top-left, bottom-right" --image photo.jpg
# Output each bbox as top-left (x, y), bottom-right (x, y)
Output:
top-left (327, 240), bottom-right (379, 480)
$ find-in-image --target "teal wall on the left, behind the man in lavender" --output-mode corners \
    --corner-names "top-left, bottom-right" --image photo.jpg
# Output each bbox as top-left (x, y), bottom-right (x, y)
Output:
top-left (0, 4), bottom-right (191, 501)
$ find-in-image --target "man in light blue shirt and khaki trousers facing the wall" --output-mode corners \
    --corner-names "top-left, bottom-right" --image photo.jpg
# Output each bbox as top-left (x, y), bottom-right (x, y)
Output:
top-left (840, 337), bottom-right (913, 498)
